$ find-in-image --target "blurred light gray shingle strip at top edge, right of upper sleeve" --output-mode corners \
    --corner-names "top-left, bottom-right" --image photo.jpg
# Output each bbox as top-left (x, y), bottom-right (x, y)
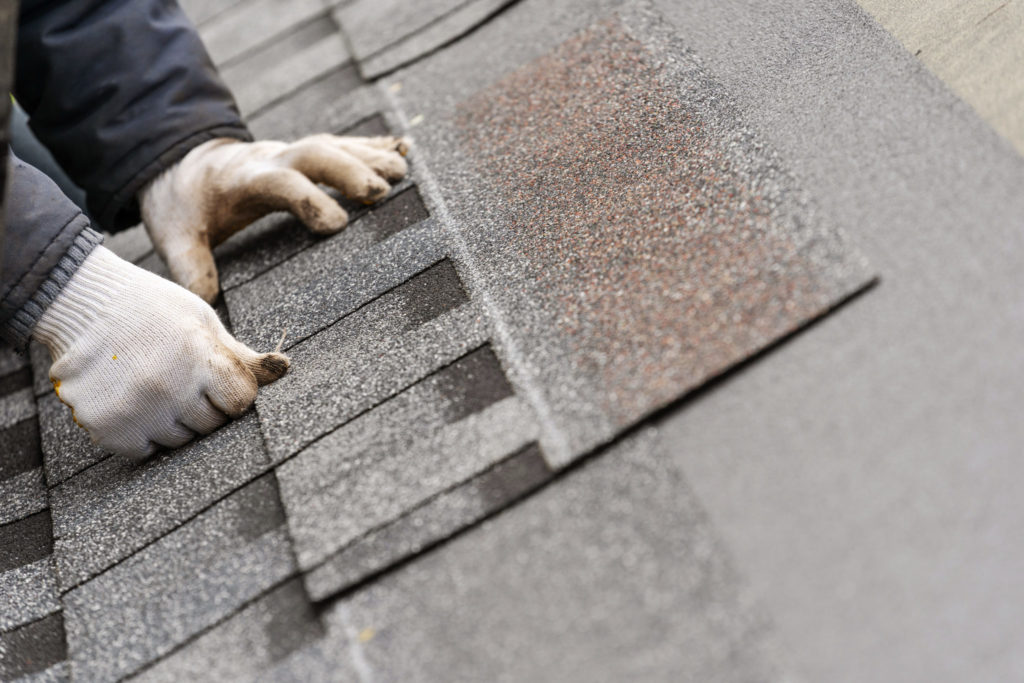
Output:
top-left (200, 0), bottom-right (324, 67)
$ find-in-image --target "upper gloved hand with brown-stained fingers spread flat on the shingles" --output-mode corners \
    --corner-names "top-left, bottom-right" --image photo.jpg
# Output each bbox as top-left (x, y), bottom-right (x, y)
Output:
top-left (139, 135), bottom-right (409, 302)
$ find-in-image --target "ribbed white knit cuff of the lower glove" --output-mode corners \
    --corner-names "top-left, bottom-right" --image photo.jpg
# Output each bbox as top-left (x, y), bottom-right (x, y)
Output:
top-left (32, 246), bottom-right (135, 360)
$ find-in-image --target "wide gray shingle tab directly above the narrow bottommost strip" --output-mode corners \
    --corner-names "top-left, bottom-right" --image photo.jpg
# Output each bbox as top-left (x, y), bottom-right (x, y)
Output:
top-left (278, 347), bottom-right (537, 569)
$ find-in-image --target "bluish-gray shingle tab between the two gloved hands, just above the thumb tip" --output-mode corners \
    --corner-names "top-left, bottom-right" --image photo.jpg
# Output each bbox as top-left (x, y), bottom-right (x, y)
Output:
top-left (224, 219), bottom-right (445, 349)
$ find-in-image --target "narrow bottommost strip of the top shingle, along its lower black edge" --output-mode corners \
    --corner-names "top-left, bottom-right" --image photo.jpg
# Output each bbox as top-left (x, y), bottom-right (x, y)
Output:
top-left (303, 444), bottom-right (553, 601)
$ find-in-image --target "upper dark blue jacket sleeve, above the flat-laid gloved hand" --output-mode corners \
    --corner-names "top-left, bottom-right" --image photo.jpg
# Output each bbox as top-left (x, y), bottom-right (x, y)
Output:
top-left (14, 0), bottom-right (252, 230)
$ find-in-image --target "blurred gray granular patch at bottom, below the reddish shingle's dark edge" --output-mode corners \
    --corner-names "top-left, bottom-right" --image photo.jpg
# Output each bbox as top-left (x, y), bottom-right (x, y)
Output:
top-left (324, 430), bottom-right (785, 683)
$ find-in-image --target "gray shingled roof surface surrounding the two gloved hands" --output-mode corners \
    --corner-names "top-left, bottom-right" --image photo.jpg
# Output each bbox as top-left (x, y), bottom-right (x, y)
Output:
top-left (0, 0), bottom-right (1024, 681)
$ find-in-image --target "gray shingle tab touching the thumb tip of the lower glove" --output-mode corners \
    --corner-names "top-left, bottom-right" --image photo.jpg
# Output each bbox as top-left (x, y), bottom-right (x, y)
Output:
top-left (249, 259), bottom-right (487, 461)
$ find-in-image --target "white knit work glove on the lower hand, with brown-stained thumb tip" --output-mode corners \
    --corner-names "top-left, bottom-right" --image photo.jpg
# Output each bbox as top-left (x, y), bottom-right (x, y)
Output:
top-left (32, 247), bottom-right (289, 458)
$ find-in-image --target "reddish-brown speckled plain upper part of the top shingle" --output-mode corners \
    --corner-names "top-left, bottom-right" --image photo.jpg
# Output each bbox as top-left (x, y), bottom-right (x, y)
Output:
top-left (396, 5), bottom-right (871, 466)
